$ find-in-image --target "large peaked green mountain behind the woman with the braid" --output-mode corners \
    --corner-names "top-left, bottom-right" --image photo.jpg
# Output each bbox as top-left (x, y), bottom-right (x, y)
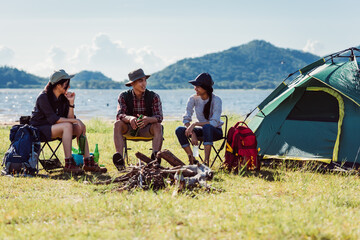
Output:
top-left (148, 40), bottom-right (320, 89)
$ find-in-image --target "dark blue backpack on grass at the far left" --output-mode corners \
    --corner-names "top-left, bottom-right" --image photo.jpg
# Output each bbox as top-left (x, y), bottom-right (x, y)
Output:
top-left (2, 124), bottom-right (40, 174)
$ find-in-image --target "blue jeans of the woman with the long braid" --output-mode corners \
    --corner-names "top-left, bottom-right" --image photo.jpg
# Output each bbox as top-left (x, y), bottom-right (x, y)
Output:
top-left (175, 124), bottom-right (222, 147)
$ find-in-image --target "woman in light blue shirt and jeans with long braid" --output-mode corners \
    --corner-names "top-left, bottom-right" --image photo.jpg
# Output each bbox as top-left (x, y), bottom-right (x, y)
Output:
top-left (175, 73), bottom-right (223, 165)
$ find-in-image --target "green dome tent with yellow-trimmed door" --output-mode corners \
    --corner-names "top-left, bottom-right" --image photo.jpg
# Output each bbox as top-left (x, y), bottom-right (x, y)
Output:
top-left (249, 48), bottom-right (360, 165)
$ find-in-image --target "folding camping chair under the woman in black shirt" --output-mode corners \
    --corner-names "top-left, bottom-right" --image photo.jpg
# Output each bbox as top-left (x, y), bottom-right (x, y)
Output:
top-left (20, 116), bottom-right (63, 173)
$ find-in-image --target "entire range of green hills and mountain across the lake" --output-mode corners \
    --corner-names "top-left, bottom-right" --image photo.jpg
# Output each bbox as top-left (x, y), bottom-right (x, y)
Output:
top-left (0, 40), bottom-right (320, 89)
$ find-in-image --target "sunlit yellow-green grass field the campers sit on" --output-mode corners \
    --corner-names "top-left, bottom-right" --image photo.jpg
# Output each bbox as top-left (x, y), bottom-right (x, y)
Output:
top-left (0, 116), bottom-right (360, 239)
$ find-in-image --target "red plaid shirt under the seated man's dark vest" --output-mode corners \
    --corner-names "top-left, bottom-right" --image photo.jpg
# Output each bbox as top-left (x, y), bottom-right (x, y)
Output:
top-left (116, 90), bottom-right (163, 123)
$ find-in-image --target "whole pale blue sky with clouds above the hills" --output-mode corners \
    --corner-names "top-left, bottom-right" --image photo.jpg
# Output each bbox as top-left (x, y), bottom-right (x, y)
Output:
top-left (0, 0), bottom-right (360, 81)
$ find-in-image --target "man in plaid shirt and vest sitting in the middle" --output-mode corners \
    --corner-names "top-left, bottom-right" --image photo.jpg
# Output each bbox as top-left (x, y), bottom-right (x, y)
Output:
top-left (113, 68), bottom-right (163, 170)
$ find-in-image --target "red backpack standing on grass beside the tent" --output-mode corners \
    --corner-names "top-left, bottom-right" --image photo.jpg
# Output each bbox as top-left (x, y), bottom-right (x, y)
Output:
top-left (224, 122), bottom-right (260, 171)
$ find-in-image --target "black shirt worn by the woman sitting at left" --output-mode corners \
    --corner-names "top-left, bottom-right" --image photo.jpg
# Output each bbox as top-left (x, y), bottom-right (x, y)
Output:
top-left (30, 91), bottom-right (69, 126)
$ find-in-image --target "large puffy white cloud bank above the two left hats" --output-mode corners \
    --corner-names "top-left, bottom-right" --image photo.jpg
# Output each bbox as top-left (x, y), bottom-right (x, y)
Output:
top-left (31, 33), bottom-right (167, 81)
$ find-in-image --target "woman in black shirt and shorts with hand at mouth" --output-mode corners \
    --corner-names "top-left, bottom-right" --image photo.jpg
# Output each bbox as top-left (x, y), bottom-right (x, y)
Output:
top-left (30, 69), bottom-right (106, 173)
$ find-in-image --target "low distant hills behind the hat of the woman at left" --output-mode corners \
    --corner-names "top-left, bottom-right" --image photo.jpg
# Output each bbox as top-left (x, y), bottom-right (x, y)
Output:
top-left (0, 66), bottom-right (125, 89)
